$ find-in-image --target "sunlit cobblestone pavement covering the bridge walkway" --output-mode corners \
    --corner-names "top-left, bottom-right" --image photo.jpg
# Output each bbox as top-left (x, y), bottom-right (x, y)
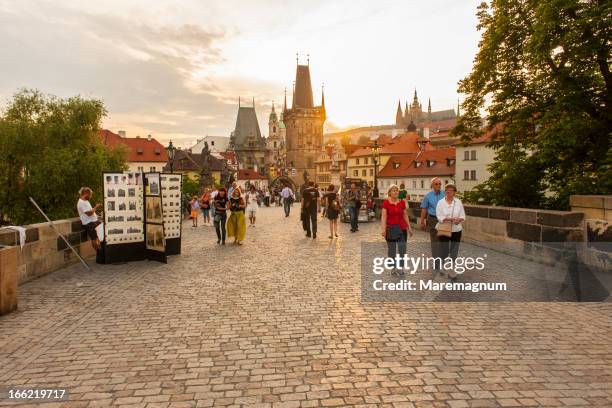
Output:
top-left (0, 208), bottom-right (612, 408)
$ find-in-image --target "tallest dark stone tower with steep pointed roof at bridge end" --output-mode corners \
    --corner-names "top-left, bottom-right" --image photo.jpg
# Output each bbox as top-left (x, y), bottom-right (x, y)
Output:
top-left (283, 58), bottom-right (326, 185)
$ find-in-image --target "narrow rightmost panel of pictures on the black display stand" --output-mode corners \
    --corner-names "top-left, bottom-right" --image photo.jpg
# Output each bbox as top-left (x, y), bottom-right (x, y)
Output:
top-left (160, 173), bottom-right (183, 255)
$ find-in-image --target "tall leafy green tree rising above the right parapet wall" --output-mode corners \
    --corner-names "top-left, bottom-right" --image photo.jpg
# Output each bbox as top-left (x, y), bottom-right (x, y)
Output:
top-left (452, 0), bottom-right (612, 209)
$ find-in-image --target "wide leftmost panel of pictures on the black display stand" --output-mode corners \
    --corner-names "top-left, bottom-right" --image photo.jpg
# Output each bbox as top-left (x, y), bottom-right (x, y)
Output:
top-left (102, 173), bottom-right (146, 263)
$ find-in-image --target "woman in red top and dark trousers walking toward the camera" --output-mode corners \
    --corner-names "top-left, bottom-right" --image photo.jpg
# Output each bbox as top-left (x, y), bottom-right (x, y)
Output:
top-left (380, 184), bottom-right (412, 276)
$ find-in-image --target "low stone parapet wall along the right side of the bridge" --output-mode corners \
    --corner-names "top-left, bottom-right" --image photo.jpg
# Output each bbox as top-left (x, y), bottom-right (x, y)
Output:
top-left (377, 196), bottom-right (612, 271)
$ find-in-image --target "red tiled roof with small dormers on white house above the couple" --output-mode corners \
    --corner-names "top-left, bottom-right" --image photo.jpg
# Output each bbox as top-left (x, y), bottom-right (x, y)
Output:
top-left (378, 147), bottom-right (455, 177)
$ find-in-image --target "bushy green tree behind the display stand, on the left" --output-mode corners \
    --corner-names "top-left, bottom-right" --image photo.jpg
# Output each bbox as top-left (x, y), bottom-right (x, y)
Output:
top-left (0, 90), bottom-right (126, 224)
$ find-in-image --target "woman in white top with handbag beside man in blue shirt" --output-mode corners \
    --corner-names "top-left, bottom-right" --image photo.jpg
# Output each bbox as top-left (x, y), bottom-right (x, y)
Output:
top-left (436, 183), bottom-right (465, 282)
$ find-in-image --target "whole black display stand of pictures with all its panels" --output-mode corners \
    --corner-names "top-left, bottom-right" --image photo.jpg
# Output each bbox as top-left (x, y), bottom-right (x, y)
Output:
top-left (101, 172), bottom-right (177, 263)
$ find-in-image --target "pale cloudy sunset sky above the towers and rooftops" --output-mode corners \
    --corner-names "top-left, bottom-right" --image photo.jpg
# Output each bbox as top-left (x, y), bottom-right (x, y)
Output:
top-left (0, 0), bottom-right (480, 146)
